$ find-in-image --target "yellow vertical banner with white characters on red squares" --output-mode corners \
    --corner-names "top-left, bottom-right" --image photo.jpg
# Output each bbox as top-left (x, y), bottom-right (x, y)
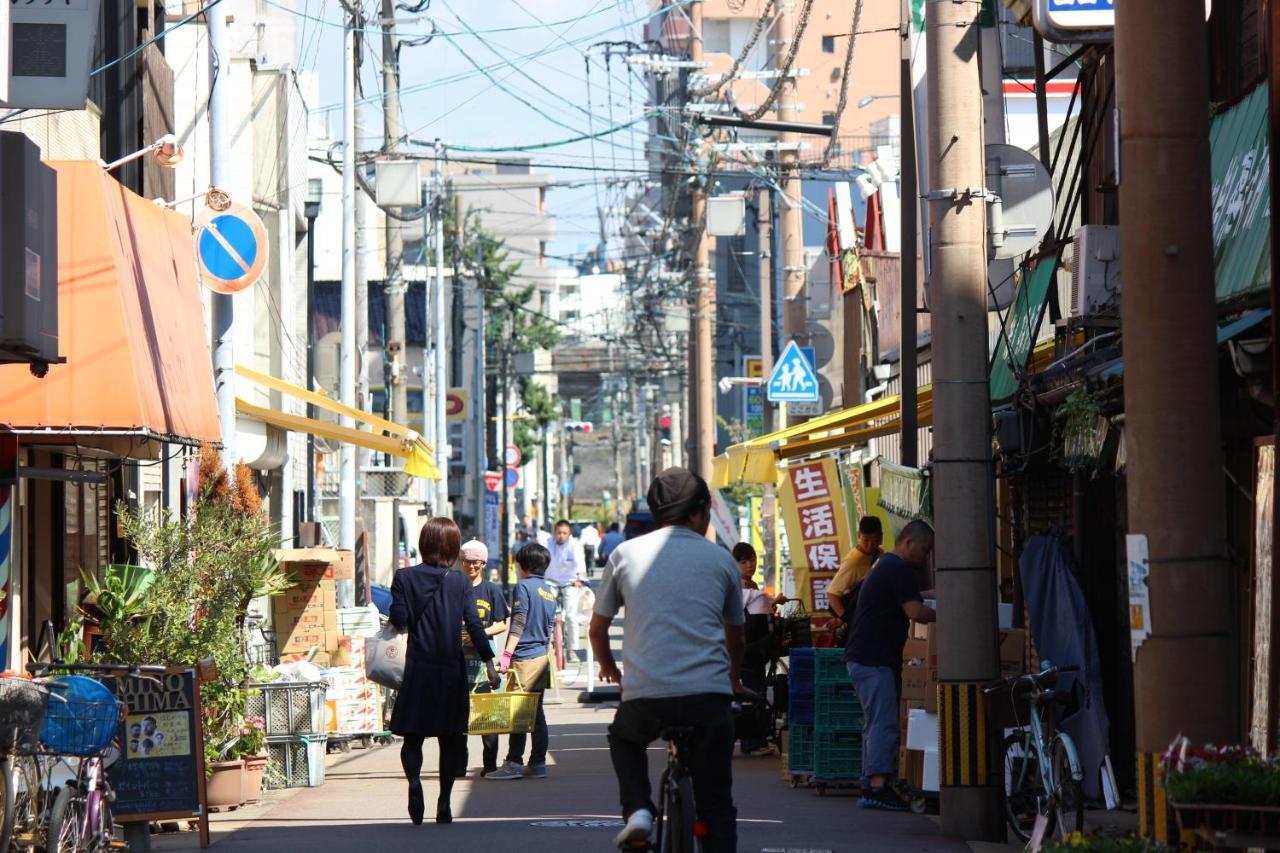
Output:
top-left (781, 457), bottom-right (852, 627)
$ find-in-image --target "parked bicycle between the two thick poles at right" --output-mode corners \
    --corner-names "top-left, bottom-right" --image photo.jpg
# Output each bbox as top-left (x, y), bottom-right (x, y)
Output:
top-left (984, 661), bottom-right (1084, 841)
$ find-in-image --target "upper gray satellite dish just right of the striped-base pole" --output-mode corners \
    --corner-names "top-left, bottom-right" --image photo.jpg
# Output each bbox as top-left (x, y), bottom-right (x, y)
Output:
top-left (987, 143), bottom-right (1053, 260)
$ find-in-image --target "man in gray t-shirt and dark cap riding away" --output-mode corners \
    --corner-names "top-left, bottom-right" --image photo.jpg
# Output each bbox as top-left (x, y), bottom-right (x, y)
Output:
top-left (590, 467), bottom-right (744, 853)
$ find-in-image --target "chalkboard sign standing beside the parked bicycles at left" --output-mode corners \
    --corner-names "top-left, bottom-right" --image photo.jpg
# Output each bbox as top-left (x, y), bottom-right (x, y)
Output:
top-left (104, 670), bottom-right (205, 822)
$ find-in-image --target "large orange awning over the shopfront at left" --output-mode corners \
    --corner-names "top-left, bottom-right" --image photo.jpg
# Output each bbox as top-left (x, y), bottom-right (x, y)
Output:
top-left (0, 160), bottom-right (220, 441)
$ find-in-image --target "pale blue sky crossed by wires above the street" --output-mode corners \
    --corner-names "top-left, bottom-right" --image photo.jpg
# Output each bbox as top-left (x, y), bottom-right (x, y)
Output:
top-left (295, 0), bottom-right (649, 265)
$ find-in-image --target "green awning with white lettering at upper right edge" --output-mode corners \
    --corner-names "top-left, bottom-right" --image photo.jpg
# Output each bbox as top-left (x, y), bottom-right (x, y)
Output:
top-left (1210, 83), bottom-right (1271, 302)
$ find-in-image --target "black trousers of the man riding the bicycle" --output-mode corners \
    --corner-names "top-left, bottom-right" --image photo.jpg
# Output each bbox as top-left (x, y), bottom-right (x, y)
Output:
top-left (609, 693), bottom-right (737, 853)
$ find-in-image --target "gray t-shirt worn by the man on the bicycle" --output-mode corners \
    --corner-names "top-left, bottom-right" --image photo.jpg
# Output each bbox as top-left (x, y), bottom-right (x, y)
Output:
top-left (595, 526), bottom-right (745, 699)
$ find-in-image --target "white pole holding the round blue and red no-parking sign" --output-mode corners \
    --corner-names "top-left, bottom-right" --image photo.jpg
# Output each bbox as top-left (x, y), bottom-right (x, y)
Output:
top-left (206, 3), bottom-right (237, 470)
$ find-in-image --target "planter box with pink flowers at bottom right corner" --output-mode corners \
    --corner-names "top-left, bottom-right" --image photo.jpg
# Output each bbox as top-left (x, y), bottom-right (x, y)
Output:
top-left (1164, 738), bottom-right (1280, 845)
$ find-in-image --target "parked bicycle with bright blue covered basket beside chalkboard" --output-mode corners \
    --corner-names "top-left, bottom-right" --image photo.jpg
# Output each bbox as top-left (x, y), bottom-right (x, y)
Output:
top-left (27, 661), bottom-right (165, 853)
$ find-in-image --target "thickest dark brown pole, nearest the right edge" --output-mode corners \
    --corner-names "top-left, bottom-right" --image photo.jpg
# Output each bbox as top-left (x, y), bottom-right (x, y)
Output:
top-left (1116, 0), bottom-right (1240, 841)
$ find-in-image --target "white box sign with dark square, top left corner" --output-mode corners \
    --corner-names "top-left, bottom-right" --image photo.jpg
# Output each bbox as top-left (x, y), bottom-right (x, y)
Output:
top-left (0, 0), bottom-right (102, 110)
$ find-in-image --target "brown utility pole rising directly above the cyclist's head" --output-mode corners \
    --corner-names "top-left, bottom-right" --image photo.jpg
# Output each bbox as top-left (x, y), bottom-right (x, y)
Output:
top-left (689, 3), bottom-right (716, 481)
